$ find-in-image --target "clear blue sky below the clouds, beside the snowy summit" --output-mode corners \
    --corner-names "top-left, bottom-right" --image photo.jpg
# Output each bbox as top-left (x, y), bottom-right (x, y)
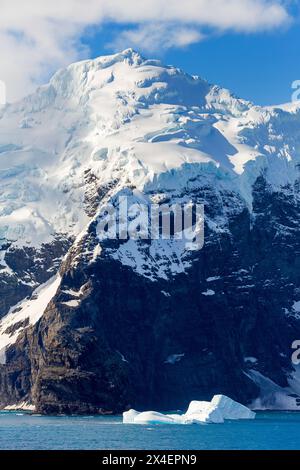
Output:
top-left (83, 23), bottom-right (300, 105)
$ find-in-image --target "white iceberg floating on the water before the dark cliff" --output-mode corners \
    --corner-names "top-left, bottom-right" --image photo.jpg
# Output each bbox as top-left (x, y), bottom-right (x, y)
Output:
top-left (123, 395), bottom-right (255, 425)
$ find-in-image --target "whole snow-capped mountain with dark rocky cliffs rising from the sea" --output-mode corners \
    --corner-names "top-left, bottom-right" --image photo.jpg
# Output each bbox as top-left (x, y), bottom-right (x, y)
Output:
top-left (0, 49), bottom-right (300, 413)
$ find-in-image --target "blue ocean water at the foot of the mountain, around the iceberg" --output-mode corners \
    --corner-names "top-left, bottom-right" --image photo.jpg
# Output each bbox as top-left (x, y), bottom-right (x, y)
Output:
top-left (0, 412), bottom-right (300, 450)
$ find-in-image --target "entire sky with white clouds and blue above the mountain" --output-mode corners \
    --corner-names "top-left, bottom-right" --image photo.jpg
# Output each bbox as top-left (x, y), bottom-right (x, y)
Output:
top-left (0, 0), bottom-right (300, 105)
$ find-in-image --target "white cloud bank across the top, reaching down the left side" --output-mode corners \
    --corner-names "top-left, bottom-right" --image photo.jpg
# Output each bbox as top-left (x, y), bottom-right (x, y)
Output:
top-left (0, 0), bottom-right (290, 99)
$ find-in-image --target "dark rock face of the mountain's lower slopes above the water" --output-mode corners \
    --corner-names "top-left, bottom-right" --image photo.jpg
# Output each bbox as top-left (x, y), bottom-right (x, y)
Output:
top-left (0, 178), bottom-right (300, 413)
